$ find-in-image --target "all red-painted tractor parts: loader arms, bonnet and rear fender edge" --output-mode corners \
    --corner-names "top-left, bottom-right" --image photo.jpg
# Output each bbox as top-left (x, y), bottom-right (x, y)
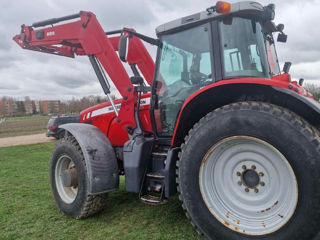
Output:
top-left (13, 11), bottom-right (312, 146)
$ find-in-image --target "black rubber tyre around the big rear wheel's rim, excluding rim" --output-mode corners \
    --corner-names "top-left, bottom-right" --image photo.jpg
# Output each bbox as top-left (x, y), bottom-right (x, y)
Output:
top-left (177, 102), bottom-right (320, 240)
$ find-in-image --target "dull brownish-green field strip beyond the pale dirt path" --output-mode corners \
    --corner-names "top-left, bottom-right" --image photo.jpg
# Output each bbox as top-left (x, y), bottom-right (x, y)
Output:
top-left (0, 116), bottom-right (50, 138)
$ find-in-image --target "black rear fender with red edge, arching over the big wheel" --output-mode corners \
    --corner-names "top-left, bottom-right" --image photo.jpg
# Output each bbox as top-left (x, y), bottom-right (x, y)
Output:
top-left (171, 84), bottom-right (320, 147)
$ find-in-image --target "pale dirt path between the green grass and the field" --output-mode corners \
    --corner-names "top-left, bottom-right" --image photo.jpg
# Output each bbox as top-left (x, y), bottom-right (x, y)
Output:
top-left (0, 133), bottom-right (55, 147)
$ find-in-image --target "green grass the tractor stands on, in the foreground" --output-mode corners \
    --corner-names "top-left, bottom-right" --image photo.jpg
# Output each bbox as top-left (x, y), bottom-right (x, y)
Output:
top-left (0, 143), bottom-right (201, 240)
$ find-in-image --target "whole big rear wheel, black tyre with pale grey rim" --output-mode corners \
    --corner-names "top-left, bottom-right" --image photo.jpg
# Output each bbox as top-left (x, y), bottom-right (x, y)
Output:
top-left (178, 102), bottom-right (320, 240)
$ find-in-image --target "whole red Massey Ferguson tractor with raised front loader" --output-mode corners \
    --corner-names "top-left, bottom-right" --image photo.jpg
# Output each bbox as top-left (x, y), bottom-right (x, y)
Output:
top-left (14, 1), bottom-right (320, 240)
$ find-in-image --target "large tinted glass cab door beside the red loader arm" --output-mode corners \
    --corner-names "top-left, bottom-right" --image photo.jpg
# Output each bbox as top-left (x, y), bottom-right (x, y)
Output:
top-left (155, 24), bottom-right (212, 136)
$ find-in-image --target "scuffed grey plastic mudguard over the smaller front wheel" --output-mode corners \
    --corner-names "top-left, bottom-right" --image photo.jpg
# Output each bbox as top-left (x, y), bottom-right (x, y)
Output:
top-left (59, 123), bottom-right (119, 195)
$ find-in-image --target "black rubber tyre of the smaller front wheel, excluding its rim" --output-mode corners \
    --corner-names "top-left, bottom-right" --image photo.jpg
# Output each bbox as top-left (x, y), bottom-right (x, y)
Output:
top-left (50, 136), bottom-right (106, 219)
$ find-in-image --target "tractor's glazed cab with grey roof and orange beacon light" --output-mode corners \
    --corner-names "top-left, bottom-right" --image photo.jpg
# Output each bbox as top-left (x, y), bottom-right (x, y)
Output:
top-left (153, 2), bottom-right (286, 136)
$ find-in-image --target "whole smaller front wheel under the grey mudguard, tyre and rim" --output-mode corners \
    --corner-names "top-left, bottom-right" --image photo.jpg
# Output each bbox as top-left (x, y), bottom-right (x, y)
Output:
top-left (50, 136), bottom-right (105, 219)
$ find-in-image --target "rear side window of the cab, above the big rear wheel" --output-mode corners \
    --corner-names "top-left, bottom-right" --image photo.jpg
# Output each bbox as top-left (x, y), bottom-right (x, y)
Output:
top-left (220, 17), bottom-right (270, 78)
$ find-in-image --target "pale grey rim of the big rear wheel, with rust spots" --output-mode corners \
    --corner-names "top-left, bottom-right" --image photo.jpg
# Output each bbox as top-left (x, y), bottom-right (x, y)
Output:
top-left (199, 136), bottom-right (298, 236)
